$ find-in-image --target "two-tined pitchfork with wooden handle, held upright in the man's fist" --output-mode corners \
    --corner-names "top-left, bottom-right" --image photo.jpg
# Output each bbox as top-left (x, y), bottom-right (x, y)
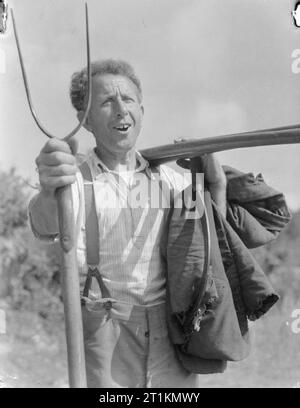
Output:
top-left (11, 3), bottom-right (92, 388)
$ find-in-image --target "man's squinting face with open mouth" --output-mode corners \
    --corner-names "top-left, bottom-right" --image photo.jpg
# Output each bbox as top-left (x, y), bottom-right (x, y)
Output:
top-left (87, 74), bottom-right (144, 153)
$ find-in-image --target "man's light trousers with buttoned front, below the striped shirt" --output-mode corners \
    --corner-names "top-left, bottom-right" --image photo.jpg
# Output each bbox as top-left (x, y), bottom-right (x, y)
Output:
top-left (82, 299), bottom-right (199, 388)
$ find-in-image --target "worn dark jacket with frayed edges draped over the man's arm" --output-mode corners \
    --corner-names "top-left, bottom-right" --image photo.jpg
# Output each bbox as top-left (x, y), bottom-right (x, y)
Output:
top-left (165, 167), bottom-right (290, 373)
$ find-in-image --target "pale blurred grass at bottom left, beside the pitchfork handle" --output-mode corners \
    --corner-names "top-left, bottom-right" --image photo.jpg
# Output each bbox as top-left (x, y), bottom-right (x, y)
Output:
top-left (0, 310), bottom-right (68, 388)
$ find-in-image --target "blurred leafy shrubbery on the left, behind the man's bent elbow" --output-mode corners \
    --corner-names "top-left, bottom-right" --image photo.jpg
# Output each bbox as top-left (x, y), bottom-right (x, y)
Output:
top-left (0, 170), bottom-right (62, 317)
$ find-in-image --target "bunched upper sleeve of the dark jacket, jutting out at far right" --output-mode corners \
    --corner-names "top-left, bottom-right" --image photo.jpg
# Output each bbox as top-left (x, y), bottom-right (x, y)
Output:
top-left (223, 166), bottom-right (291, 248)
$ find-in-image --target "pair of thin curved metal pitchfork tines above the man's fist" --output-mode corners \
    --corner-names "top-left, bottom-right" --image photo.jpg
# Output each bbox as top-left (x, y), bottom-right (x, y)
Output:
top-left (11, 3), bottom-right (92, 141)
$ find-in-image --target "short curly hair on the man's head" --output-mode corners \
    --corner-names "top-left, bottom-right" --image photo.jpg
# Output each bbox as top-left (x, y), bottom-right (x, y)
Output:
top-left (70, 59), bottom-right (142, 111)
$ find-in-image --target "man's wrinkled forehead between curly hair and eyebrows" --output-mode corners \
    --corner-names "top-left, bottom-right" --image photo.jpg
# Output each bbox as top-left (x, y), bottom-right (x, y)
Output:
top-left (92, 74), bottom-right (138, 96)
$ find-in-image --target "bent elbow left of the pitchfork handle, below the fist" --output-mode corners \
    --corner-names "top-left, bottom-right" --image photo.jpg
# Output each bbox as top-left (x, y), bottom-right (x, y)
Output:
top-left (29, 192), bottom-right (58, 236)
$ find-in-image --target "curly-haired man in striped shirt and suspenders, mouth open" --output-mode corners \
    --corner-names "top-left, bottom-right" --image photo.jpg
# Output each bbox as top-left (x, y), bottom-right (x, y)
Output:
top-left (29, 60), bottom-right (226, 387)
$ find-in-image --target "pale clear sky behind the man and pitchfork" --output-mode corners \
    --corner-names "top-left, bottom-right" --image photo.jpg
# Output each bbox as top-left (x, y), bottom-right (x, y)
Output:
top-left (0, 0), bottom-right (300, 209)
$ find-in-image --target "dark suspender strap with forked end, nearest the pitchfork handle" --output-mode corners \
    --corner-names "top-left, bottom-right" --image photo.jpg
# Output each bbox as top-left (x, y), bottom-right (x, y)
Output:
top-left (79, 162), bottom-right (111, 298)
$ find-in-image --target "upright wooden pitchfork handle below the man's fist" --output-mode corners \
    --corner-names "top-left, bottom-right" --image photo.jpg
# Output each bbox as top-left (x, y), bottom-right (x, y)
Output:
top-left (56, 186), bottom-right (87, 388)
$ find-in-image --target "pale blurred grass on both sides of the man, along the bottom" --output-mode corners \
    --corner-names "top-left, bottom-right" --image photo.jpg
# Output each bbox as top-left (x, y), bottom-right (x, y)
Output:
top-left (0, 279), bottom-right (300, 388)
